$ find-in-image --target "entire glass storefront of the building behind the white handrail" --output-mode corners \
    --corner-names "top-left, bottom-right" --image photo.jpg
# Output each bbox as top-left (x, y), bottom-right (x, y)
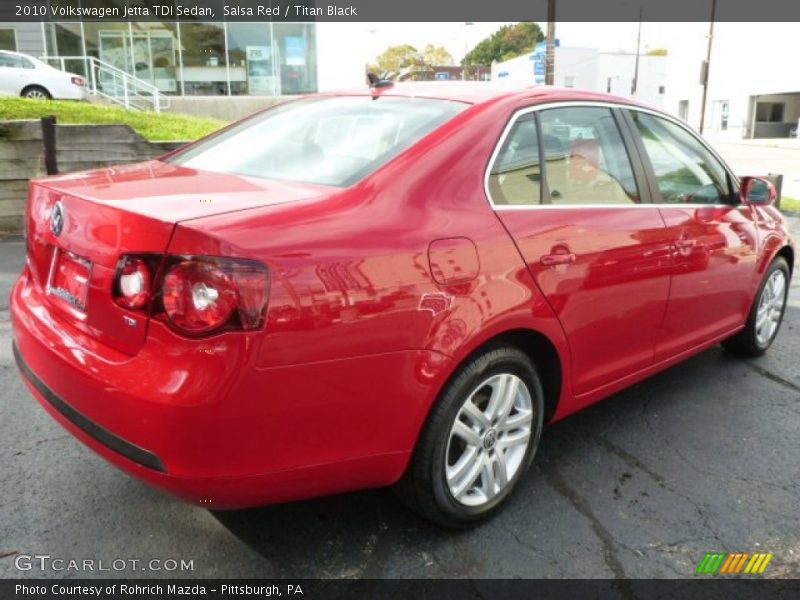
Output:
top-left (28, 22), bottom-right (317, 96)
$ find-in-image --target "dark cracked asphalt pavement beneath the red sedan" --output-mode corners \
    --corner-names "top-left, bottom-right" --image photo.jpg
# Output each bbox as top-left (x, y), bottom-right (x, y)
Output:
top-left (0, 221), bottom-right (800, 578)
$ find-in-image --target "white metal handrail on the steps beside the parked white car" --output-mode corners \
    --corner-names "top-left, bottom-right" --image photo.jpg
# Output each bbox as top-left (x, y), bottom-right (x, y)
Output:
top-left (40, 56), bottom-right (169, 112)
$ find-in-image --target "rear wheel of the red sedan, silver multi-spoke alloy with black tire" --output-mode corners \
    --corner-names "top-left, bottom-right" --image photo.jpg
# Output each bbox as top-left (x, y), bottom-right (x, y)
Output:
top-left (397, 345), bottom-right (544, 527)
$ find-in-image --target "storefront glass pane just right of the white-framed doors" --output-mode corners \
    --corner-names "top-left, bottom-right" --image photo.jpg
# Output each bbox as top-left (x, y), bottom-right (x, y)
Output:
top-left (180, 23), bottom-right (228, 96)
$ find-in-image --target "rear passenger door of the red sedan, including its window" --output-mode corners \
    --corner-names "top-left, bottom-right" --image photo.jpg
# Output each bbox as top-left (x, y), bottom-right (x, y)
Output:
top-left (486, 103), bottom-right (670, 395)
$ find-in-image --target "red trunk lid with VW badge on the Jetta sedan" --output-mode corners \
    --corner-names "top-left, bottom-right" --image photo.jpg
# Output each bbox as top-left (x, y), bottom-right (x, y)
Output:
top-left (27, 161), bottom-right (332, 355)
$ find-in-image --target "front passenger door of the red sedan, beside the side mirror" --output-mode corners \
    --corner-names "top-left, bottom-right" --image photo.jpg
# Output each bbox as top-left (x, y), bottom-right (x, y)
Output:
top-left (626, 110), bottom-right (758, 360)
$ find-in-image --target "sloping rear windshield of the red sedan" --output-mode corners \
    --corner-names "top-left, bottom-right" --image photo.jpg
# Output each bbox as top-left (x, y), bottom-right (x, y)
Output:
top-left (169, 96), bottom-right (468, 186)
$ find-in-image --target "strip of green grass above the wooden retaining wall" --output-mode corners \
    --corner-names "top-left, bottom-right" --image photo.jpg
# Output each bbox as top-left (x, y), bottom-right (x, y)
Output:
top-left (0, 98), bottom-right (226, 141)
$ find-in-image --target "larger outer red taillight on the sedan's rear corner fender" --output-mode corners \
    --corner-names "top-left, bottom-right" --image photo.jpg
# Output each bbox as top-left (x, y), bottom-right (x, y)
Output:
top-left (161, 258), bottom-right (268, 335)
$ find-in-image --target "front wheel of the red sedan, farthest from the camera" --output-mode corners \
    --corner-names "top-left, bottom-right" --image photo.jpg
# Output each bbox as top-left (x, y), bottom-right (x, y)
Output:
top-left (722, 256), bottom-right (791, 356)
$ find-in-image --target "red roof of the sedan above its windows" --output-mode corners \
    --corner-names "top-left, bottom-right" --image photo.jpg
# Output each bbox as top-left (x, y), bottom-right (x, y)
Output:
top-left (318, 81), bottom-right (651, 108)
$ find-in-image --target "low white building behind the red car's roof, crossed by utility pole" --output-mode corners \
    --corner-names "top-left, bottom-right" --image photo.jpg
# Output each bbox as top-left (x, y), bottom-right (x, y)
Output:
top-left (492, 46), bottom-right (667, 107)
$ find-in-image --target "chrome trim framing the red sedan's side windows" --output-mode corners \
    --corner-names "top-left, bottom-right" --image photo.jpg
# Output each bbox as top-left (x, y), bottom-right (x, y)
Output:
top-left (483, 100), bottom-right (741, 210)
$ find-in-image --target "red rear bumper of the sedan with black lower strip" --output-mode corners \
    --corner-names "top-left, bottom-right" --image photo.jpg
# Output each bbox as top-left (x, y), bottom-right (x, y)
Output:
top-left (11, 269), bottom-right (438, 508)
